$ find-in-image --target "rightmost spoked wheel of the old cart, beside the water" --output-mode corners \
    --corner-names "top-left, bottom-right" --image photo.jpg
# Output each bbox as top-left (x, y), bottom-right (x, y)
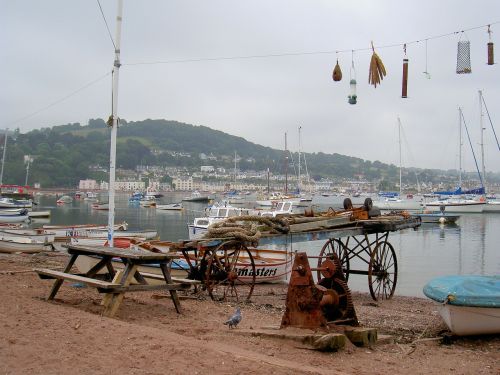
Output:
top-left (368, 241), bottom-right (398, 301)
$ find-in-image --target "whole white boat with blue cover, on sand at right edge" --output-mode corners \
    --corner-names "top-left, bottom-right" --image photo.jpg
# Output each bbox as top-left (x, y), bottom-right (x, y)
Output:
top-left (423, 275), bottom-right (500, 336)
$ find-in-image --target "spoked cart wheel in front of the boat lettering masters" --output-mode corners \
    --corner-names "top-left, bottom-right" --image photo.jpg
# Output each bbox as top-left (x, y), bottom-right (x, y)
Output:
top-left (205, 241), bottom-right (255, 302)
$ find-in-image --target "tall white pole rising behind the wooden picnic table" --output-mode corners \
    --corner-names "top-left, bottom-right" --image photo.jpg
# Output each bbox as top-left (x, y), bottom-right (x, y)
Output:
top-left (108, 0), bottom-right (123, 247)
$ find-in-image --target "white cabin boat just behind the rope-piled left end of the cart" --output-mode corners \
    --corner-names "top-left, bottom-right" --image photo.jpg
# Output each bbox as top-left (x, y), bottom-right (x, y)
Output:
top-left (188, 202), bottom-right (253, 240)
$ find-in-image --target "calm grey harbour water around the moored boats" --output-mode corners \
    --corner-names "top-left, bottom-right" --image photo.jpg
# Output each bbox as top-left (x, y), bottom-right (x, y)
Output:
top-left (32, 193), bottom-right (500, 297)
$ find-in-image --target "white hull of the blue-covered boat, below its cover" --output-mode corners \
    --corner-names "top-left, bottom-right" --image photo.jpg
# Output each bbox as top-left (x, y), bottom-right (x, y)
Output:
top-left (438, 304), bottom-right (500, 336)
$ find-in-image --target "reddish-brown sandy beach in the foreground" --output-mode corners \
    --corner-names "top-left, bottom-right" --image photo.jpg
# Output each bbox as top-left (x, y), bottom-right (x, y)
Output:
top-left (0, 253), bottom-right (500, 374)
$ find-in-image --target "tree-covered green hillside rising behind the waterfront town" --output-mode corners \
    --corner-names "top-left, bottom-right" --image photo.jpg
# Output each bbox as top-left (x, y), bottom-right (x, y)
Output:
top-left (0, 119), bottom-right (499, 187)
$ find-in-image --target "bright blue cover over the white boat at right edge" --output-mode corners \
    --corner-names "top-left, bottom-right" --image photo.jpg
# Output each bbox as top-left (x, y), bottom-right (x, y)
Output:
top-left (423, 275), bottom-right (500, 307)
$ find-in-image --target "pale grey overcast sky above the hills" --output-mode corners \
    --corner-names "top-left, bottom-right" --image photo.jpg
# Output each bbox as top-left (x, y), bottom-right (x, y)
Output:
top-left (0, 0), bottom-right (500, 172)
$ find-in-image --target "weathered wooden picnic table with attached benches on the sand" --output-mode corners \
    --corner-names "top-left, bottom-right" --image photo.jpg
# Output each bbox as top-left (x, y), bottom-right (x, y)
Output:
top-left (34, 245), bottom-right (191, 317)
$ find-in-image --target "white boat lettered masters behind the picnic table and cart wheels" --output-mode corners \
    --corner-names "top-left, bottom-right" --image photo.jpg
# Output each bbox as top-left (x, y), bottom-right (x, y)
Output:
top-left (75, 247), bottom-right (294, 284)
